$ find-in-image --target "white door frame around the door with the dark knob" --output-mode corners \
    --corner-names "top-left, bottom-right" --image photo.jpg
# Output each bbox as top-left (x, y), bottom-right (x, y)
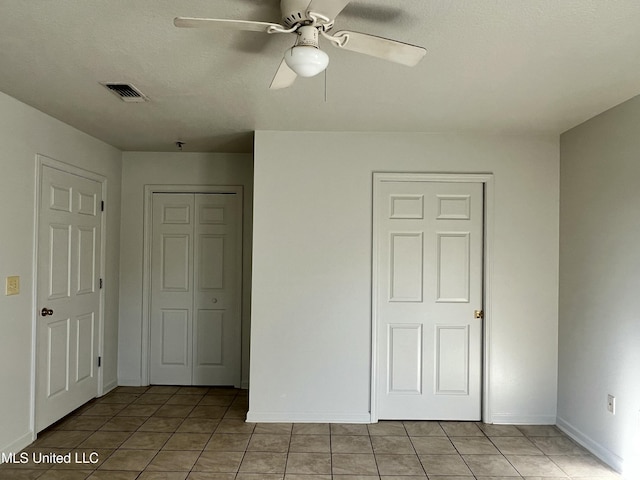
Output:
top-left (29, 153), bottom-right (108, 439)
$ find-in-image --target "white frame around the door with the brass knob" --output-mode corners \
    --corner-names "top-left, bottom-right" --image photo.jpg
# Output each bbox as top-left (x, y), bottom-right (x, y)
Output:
top-left (370, 172), bottom-right (494, 423)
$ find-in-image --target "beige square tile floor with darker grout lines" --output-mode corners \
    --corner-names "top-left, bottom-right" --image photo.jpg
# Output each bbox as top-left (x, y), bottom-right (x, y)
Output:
top-left (0, 386), bottom-right (617, 480)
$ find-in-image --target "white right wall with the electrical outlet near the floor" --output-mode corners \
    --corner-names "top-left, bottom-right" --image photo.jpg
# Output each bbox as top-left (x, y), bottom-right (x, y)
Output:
top-left (558, 96), bottom-right (640, 472)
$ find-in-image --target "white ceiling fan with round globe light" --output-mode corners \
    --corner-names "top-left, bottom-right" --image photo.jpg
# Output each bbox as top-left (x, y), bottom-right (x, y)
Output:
top-left (173, 0), bottom-right (426, 89)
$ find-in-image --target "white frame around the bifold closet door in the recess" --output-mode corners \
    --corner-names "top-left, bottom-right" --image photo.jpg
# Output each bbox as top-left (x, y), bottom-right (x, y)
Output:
top-left (140, 185), bottom-right (244, 385)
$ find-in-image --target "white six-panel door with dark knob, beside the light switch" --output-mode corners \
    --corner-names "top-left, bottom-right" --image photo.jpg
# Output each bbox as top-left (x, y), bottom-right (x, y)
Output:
top-left (35, 165), bottom-right (102, 432)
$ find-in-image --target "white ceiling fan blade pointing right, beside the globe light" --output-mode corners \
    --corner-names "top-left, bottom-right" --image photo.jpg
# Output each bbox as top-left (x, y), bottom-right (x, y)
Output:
top-left (333, 30), bottom-right (427, 67)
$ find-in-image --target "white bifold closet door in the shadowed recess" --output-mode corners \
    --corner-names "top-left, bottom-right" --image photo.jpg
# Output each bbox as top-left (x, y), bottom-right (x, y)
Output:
top-left (150, 193), bottom-right (241, 385)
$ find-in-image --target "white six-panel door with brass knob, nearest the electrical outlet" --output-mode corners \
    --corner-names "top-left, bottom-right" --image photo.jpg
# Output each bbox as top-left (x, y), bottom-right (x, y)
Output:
top-left (374, 180), bottom-right (484, 420)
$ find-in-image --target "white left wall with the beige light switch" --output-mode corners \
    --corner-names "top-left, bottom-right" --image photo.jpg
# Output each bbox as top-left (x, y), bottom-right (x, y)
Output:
top-left (0, 93), bottom-right (121, 452)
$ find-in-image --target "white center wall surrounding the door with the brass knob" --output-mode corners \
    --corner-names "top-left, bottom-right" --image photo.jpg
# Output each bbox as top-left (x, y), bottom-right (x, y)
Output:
top-left (249, 131), bottom-right (559, 423)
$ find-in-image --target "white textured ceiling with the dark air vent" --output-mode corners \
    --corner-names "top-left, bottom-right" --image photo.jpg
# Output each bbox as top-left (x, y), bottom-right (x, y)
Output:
top-left (0, 0), bottom-right (640, 152)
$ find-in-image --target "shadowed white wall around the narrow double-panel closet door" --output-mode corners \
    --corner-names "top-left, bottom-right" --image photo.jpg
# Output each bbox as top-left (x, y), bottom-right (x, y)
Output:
top-left (118, 152), bottom-right (253, 385)
